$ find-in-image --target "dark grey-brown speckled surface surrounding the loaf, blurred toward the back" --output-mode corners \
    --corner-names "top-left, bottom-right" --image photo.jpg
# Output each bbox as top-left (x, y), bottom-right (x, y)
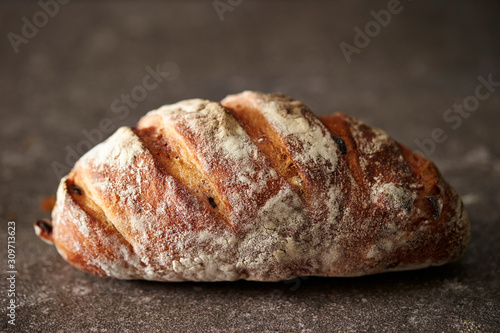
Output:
top-left (0, 0), bottom-right (500, 332)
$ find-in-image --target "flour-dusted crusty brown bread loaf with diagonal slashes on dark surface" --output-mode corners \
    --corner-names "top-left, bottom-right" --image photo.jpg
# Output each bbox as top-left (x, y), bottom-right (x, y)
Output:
top-left (35, 91), bottom-right (469, 281)
